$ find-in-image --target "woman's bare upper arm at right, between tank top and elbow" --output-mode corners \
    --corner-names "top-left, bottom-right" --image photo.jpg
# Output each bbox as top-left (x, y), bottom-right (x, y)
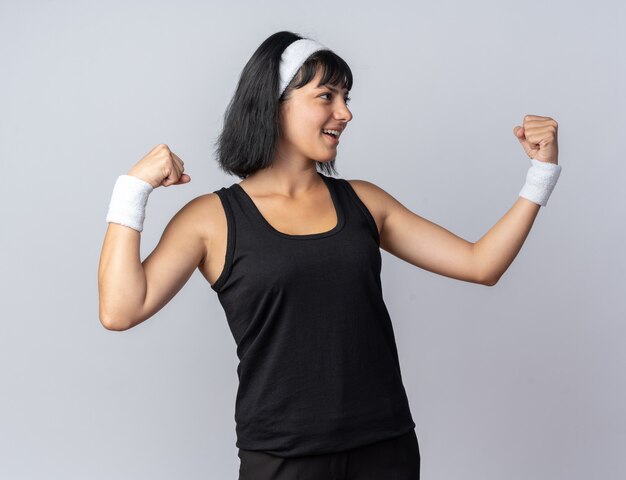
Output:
top-left (380, 191), bottom-right (484, 284)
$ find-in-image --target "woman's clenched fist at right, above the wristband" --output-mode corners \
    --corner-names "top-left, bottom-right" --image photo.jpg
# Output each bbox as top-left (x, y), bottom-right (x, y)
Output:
top-left (513, 115), bottom-right (559, 165)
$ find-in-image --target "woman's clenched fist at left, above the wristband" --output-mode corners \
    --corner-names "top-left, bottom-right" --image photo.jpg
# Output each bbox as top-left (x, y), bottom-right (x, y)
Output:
top-left (128, 143), bottom-right (191, 188)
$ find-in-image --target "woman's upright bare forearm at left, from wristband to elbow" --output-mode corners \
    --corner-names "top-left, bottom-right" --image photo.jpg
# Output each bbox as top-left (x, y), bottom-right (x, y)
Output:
top-left (98, 223), bottom-right (146, 330)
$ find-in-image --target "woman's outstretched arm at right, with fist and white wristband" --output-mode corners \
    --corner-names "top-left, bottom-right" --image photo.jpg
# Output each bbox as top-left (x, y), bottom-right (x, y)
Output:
top-left (350, 115), bottom-right (560, 286)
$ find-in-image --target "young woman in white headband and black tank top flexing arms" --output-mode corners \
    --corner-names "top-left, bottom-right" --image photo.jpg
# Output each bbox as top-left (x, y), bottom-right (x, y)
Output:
top-left (99, 32), bottom-right (560, 480)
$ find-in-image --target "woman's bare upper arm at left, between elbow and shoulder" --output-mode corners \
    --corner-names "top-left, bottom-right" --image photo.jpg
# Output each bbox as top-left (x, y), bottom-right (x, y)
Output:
top-left (135, 197), bottom-right (206, 321)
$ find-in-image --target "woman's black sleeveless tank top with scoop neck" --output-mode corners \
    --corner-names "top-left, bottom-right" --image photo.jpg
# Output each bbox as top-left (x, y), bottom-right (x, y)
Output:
top-left (211, 172), bottom-right (415, 457)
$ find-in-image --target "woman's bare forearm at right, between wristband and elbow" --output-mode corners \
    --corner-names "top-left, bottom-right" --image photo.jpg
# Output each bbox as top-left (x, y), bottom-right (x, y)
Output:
top-left (474, 197), bottom-right (541, 284)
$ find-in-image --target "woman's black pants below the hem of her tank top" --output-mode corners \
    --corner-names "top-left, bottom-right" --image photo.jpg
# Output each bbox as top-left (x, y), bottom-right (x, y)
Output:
top-left (238, 430), bottom-right (420, 480)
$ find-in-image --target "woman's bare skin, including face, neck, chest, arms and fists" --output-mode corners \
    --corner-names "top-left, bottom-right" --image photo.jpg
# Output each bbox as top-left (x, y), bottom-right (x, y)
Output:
top-left (98, 65), bottom-right (558, 331)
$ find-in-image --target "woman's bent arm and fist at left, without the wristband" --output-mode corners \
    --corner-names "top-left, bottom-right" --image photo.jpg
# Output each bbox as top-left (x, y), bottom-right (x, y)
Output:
top-left (98, 144), bottom-right (206, 330)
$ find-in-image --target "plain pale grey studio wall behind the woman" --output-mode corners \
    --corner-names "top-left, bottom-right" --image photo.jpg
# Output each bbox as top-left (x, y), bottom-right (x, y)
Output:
top-left (0, 0), bottom-right (626, 480)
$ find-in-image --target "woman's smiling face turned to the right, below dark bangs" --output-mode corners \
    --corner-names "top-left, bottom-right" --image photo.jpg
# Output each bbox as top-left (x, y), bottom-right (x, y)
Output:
top-left (276, 68), bottom-right (352, 162)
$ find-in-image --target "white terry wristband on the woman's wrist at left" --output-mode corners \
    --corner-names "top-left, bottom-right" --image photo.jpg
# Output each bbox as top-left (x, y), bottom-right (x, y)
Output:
top-left (106, 175), bottom-right (154, 232)
